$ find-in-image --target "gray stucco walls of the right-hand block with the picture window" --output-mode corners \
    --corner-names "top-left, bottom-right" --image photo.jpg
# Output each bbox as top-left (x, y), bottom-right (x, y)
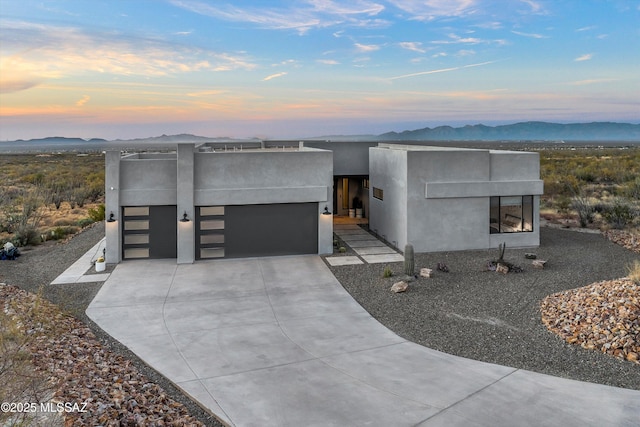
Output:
top-left (370, 145), bottom-right (542, 252)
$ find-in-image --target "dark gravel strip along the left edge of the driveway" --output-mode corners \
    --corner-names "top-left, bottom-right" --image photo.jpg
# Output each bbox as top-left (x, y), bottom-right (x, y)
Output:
top-left (0, 223), bottom-right (223, 427)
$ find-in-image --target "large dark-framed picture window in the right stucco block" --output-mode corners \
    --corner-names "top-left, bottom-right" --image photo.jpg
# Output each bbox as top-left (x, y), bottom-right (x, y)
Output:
top-left (489, 196), bottom-right (533, 234)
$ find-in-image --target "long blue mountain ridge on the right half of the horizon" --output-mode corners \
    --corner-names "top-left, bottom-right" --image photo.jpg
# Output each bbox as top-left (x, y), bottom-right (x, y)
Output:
top-left (378, 122), bottom-right (640, 141)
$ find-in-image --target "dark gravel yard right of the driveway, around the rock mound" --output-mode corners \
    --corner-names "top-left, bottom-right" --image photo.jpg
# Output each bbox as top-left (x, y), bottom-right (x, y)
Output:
top-left (329, 228), bottom-right (640, 390)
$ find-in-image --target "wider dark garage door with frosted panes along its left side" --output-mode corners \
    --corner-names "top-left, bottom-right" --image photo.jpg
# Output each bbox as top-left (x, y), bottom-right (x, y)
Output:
top-left (196, 203), bottom-right (318, 259)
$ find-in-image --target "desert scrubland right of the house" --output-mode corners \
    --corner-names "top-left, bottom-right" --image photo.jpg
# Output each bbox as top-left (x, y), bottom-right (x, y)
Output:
top-left (540, 147), bottom-right (640, 234)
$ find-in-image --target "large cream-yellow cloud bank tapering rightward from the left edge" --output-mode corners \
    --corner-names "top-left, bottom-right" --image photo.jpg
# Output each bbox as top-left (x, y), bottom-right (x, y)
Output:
top-left (0, 21), bottom-right (255, 93)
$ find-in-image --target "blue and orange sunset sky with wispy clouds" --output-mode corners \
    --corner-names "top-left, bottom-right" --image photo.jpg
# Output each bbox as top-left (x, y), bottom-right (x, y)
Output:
top-left (0, 0), bottom-right (640, 140)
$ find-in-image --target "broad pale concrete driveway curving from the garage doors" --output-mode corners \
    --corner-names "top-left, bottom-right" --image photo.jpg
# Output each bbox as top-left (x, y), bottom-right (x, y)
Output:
top-left (87, 256), bottom-right (640, 427)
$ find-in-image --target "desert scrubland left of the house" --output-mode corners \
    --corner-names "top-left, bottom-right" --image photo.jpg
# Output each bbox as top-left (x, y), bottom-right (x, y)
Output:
top-left (0, 153), bottom-right (104, 246)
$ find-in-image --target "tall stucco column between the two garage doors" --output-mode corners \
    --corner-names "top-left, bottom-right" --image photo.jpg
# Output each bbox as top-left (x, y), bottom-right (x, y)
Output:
top-left (176, 144), bottom-right (195, 264)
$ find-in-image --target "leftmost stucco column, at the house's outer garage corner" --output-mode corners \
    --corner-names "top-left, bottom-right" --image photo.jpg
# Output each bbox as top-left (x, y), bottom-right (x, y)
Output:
top-left (104, 151), bottom-right (122, 264)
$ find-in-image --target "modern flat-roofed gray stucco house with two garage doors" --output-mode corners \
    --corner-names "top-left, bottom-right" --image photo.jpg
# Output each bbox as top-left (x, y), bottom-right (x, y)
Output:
top-left (105, 141), bottom-right (542, 263)
